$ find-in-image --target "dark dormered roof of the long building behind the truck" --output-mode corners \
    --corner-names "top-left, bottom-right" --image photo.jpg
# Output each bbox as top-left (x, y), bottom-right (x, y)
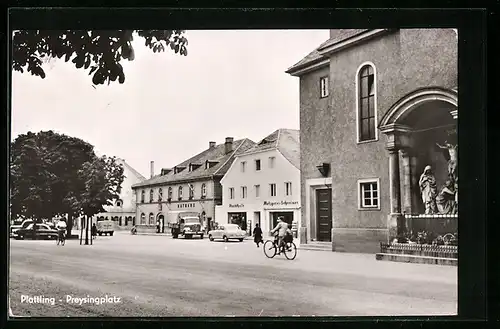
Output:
top-left (132, 138), bottom-right (255, 188)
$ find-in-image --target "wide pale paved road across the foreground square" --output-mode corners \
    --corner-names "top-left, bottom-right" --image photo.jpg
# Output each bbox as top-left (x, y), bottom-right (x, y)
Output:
top-left (9, 233), bottom-right (457, 317)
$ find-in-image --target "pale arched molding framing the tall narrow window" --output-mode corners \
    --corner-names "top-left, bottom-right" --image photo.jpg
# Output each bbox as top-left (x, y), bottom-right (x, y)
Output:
top-left (355, 61), bottom-right (379, 144)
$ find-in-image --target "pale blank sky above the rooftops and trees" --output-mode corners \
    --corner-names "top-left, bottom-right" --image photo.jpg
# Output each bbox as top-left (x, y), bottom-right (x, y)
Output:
top-left (11, 30), bottom-right (329, 177)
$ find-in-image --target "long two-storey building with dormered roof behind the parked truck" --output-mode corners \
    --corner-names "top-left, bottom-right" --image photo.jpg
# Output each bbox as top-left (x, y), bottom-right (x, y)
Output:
top-left (132, 137), bottom-right (255, 232)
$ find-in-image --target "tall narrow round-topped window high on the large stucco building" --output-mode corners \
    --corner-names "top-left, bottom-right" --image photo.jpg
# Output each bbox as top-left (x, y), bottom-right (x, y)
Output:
top-left (357, 64), bottom-right (377, 142)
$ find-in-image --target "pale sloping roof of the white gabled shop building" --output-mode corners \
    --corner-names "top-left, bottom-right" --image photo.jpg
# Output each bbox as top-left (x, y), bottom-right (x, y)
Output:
top-left (241, 128), bottom-right (300, 169)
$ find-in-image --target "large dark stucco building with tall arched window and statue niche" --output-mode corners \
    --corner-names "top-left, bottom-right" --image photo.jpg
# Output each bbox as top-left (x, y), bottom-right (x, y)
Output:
top-left (287, 29), bottom-right (458, 252)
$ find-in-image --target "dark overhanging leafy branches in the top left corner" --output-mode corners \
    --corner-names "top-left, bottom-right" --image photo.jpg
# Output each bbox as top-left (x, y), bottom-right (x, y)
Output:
top-left (12, 30), bottom-right (187, 85)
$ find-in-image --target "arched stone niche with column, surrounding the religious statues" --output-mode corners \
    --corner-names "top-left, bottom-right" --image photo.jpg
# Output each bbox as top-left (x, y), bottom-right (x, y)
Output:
top-left (379, 87), bottom-right (458, 236)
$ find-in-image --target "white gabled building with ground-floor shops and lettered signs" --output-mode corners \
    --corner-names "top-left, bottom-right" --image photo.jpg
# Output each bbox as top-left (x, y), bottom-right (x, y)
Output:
top-left (216, 129), bottom-right (301, 240)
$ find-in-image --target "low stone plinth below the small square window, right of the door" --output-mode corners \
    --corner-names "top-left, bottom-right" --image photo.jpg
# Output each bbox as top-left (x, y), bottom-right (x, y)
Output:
top-left (332, 228), bottom-right (389, 254)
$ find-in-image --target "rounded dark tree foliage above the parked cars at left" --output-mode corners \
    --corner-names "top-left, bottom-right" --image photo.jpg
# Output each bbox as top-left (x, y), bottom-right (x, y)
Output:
top-left (10, 131), bottom-right (124, 232)
